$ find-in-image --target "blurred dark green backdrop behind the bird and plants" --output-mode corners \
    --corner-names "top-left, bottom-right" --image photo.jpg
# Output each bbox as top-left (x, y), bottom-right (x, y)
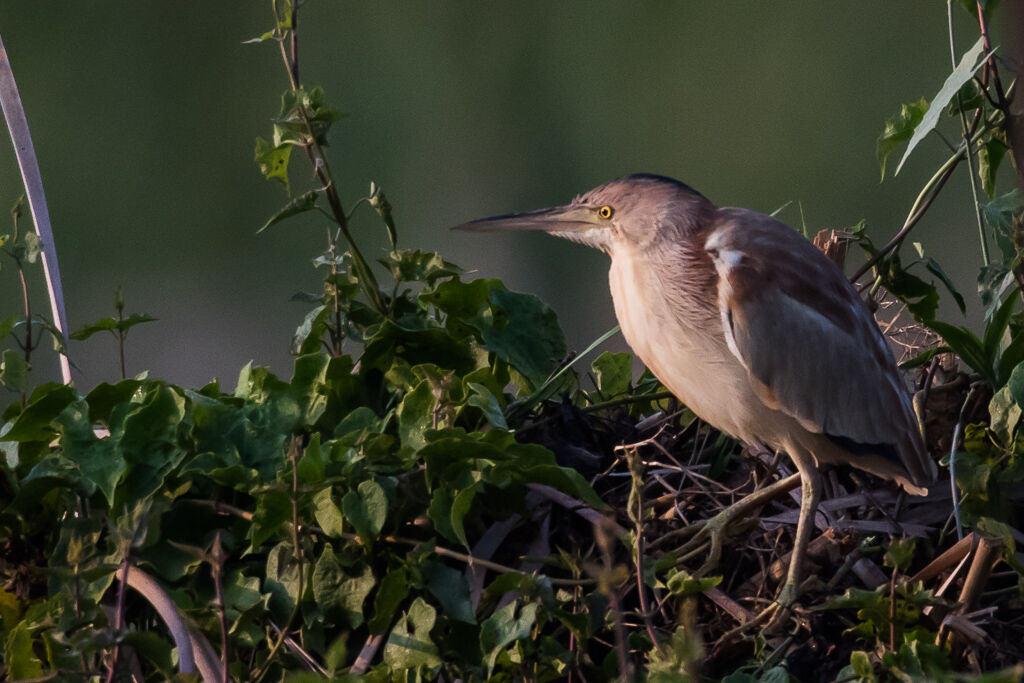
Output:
top-left (0, 0), bottom-right (1012, 389)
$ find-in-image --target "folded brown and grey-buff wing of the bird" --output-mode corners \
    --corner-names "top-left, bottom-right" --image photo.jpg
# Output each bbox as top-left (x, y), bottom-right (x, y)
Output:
top-left (706, 208), bottom-right (930, 479)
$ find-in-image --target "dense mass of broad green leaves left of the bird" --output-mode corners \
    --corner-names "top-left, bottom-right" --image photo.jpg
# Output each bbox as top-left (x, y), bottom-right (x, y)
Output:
top-left (0, 233), bottom-right (663, 678)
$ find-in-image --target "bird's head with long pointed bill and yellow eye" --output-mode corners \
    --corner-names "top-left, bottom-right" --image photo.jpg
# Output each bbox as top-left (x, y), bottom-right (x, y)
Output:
top-left (453, 174), bottom-right (714, 254)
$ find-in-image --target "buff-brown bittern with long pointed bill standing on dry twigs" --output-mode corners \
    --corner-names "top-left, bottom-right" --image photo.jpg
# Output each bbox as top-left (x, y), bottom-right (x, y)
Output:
top-left (453, 173), bottom-right (937, 623)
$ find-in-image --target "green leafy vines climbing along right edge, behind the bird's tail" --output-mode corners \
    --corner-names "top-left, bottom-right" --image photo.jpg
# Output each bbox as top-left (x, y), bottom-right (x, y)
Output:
top-left (855, 0), bottom-right (1024, 540)
